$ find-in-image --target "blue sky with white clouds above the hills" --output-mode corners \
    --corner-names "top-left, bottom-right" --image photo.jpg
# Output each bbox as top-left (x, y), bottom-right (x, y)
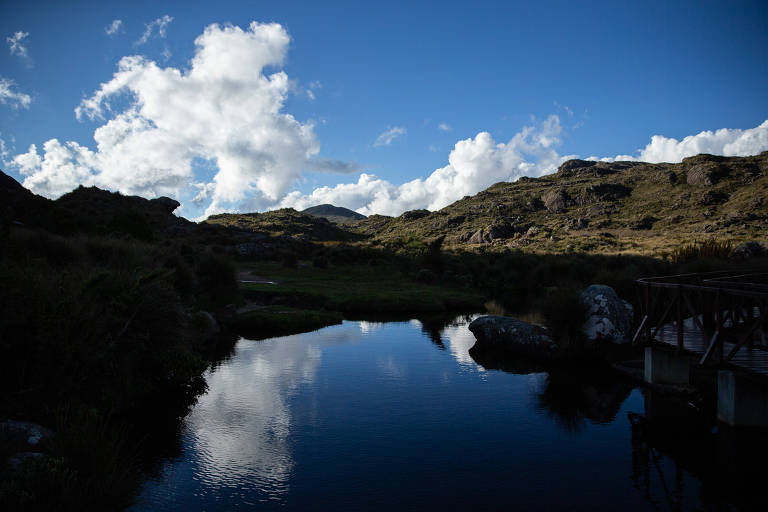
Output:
top-left (0, 0), bottom-right (768, 219)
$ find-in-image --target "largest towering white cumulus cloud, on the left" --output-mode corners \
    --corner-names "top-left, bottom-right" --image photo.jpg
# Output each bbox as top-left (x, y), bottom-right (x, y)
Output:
top-left (14, 22), bottom-right (319, 215)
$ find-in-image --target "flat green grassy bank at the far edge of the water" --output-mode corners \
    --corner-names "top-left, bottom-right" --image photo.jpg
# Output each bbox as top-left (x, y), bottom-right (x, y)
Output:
top-left (243, 262), bottom-right (483, 313)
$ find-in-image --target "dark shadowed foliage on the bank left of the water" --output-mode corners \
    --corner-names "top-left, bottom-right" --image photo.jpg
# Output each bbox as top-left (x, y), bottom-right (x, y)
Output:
top-left (0, 228), bottom-right (238, 510)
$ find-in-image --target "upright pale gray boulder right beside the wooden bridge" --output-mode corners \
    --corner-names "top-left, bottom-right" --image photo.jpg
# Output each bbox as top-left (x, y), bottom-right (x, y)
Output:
top-left (581, 284), bottom-right (632, 345)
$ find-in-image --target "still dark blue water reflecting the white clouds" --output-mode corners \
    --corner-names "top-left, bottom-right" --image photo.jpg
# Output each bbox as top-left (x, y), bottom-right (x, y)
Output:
top-left (133, 317), bottom-right (768, 511)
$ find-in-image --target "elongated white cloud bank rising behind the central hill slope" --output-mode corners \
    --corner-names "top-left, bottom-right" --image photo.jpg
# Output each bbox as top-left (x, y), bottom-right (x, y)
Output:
top-left (281, 115), bottom-right (573, 215)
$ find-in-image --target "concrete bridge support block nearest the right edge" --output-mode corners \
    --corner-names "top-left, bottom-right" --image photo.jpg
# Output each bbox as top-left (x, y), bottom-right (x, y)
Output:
top-left (717, 370), bottom-right (768, 427)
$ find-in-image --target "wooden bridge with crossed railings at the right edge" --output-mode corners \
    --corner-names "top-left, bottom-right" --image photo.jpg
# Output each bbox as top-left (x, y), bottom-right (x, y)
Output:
top-left (632, 271), bottom-right (768, 376)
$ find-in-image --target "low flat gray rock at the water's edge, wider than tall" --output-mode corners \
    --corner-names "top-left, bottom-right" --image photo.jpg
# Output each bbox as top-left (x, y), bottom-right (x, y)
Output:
top-left (469, 315), bottom-right (558, 358)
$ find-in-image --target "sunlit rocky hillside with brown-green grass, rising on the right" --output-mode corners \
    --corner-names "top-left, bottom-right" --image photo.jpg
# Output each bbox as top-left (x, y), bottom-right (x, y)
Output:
top-left (350, 151), bottom-right (768, 254)
